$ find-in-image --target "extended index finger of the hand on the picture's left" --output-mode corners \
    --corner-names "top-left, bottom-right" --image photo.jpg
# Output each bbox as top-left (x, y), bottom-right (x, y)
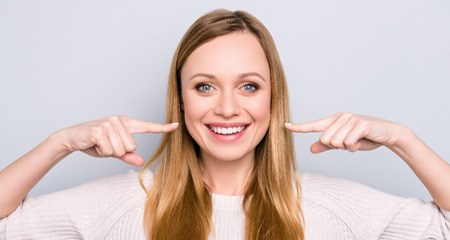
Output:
top-left (124, 118), bottom-right (179, 133)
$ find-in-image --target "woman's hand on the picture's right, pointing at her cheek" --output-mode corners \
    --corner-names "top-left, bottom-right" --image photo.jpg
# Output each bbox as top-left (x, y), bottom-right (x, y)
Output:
top-left (285, 113), bottom-right (406, 153)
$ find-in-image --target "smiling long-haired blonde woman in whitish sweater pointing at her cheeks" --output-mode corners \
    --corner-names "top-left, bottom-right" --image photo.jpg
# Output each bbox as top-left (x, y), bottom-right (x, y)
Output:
top-left (0, 10), bottom-right (450, 239)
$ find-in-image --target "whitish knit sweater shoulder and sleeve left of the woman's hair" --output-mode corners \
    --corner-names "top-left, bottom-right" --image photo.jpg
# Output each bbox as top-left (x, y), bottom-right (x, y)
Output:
top-left (0, 171), bottom-right (152, 240)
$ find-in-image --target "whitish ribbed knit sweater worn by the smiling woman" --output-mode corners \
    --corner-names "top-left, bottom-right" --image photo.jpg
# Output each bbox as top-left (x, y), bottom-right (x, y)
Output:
top-left (0, 171), bottom-right (450, 240)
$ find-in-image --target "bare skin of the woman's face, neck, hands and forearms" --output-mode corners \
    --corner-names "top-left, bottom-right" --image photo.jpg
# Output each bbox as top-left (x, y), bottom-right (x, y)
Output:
top-left (0, 33), bottom-right (450, 218)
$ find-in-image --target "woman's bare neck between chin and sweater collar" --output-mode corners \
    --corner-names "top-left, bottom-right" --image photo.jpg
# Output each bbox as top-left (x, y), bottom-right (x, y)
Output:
top-left (201, 151), bottom-right (255, 195)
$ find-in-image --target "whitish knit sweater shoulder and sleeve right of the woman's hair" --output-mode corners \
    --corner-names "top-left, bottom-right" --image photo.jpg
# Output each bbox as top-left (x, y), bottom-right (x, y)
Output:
top-left (302, 174), bottom-right (450, 239)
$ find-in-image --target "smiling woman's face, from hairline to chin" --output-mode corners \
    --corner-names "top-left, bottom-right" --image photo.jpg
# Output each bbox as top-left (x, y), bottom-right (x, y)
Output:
top-left (181, 32), bottom-right (271, 161)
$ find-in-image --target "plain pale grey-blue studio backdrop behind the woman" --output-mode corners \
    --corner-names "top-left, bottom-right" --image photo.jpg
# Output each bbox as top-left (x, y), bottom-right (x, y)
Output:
top-left (0, 0), bottom-right (450, 201)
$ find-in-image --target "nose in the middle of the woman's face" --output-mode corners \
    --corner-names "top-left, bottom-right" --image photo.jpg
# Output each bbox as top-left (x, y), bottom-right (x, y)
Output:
top-left (214, 90), bottom-right (241, 118)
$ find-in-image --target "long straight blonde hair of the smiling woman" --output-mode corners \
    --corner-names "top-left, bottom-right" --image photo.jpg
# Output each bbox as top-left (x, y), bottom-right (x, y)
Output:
top-left (141, 10), bottom-right (304, 240)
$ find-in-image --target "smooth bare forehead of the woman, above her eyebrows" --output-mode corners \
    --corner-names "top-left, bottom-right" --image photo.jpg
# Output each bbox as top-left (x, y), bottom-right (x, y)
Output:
top-left (181, 32), bottom-right (270, 80)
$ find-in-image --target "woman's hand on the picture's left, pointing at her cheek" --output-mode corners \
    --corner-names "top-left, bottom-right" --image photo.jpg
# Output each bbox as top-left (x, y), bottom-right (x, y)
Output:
top-left (56, 116), bottom-right (178, 166)
